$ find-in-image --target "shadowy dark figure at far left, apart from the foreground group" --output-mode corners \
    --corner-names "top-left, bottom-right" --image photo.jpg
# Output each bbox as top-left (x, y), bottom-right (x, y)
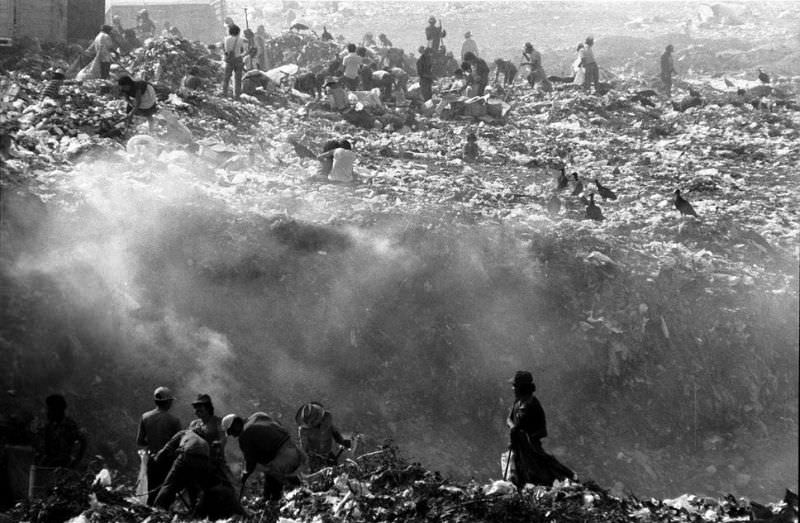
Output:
top-left (34, 394), bottom-right (88, 469)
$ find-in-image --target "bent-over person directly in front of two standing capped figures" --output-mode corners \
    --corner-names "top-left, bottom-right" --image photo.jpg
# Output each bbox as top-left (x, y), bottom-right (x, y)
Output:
top-left (153, 429), bottom-right (215, 510)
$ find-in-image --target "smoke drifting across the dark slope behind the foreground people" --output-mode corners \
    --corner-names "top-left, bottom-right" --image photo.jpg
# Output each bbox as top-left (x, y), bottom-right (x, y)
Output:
top-left (0, 158), bottom-right (797, 500)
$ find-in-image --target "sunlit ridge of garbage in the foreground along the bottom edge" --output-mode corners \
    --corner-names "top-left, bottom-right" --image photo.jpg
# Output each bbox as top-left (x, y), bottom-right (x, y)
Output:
top-left (4, 447), bottom-right (798, 523)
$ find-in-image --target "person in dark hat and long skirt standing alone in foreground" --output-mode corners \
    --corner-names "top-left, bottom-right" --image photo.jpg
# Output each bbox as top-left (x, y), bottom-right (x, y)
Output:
top-left (506, 370), bottom-right (575, 488)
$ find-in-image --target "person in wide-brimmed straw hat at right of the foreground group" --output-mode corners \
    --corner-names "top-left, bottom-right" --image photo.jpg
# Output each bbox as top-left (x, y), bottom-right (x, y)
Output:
top-left (294, 402), bottom-right (351, 472)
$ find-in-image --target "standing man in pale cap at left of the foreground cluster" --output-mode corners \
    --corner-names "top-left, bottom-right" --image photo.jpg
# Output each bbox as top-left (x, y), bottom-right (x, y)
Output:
top-left (136, 387), bottom-right (181, 506)
